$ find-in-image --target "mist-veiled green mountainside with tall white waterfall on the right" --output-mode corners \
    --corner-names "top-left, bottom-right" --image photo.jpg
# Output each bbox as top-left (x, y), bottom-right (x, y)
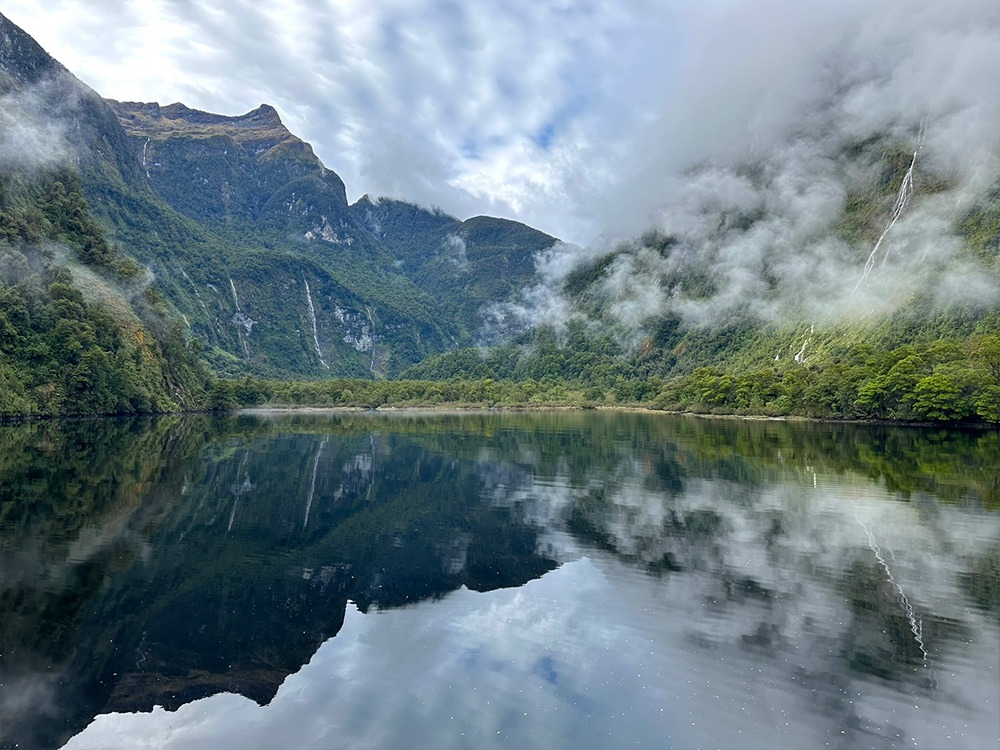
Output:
top-left (404, 137), bottom-right (1000, 422)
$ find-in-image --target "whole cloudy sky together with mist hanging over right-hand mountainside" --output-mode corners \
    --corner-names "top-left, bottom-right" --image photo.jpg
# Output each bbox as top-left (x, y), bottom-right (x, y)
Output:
top-left (5, 0), bottom-right (1000, 344)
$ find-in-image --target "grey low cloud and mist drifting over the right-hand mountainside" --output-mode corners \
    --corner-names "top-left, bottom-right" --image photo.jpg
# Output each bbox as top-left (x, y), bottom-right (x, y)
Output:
top-left (508, 2), bottom-right (1000, 341)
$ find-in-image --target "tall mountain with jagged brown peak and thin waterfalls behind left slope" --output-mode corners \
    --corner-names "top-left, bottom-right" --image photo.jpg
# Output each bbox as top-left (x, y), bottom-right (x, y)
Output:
top-left (95, 102), bottom-right (468, 376)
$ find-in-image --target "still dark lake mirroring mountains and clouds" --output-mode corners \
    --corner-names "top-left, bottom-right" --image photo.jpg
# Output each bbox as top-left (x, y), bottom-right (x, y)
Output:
top-left (0, 413), bottom-right (1000, 750)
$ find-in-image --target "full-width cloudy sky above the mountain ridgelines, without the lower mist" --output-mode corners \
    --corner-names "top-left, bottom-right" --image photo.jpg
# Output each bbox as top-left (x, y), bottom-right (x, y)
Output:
top-left (3, 0), bottom-right (1000, 248)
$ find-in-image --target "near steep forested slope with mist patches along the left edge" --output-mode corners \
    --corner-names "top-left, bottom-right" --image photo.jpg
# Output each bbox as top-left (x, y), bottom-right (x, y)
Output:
top-left (0, 17), bottom-right (209, 416)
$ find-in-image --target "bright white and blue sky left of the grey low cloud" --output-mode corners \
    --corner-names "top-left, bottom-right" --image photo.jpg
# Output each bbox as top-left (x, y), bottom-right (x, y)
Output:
top-left (3, 0), bottom-right (686, 242)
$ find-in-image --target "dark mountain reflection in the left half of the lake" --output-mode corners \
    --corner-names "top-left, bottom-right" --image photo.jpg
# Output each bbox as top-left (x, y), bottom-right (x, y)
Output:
top-left (0, 416), bottom-right (556, 748)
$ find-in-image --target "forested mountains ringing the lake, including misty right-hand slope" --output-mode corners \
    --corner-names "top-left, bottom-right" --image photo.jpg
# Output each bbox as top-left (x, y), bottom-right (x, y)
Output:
top-left (0, 10), bottom-right (1000, 421)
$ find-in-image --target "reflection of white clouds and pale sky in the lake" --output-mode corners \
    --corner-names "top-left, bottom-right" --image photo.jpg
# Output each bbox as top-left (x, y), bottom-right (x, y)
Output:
top-left (60, 476), bottom-right (1000, 750)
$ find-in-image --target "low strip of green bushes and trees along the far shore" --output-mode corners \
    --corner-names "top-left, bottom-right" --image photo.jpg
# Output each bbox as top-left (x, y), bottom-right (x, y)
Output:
top-left (210, 335), bottom-right (1000, 424)
